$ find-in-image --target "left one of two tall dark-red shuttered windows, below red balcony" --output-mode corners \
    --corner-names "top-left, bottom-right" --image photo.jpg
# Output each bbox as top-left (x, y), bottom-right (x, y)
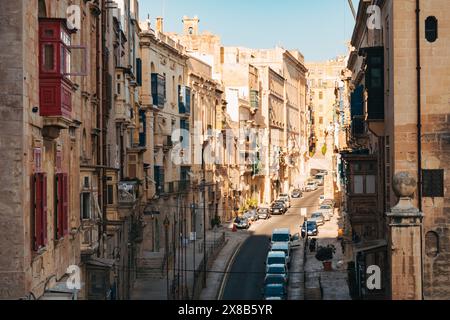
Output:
top-left (31, 173), bottom-right (47, 251)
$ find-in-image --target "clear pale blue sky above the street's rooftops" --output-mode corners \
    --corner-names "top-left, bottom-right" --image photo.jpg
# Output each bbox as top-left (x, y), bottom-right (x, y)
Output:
top-left (139, 0), bottom-right (358, 61)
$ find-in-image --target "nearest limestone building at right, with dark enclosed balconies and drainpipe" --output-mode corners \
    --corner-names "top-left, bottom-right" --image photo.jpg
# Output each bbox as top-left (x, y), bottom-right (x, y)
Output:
top-left (344, 0), bottom-right (450, 300)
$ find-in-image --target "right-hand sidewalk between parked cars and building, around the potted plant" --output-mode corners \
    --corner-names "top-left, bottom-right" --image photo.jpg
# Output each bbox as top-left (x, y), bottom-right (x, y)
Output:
top-left (305, 210), bottom-right (351, 300)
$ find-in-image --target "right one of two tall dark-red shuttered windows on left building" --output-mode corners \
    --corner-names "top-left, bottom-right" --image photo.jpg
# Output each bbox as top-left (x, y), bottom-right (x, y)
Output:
top-left (55, 173), bottom-right (69, 240)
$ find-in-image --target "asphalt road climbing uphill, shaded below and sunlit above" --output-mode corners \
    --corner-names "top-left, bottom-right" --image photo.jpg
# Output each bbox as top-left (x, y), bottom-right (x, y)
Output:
top-left (222, 188), bottom-right (323, 301)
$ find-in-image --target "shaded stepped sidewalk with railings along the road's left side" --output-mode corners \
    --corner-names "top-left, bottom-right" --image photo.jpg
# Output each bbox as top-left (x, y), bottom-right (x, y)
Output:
top-left (131, 223), bottom-right (250, 300)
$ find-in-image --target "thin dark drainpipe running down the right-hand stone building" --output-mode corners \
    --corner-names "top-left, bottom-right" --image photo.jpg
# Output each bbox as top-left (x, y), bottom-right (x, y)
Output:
top-left (416, 0), bottom-right (425, 300)
